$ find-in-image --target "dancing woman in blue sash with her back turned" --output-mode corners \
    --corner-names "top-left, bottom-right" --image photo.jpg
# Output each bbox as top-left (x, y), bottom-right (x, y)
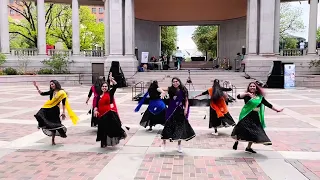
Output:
top-left (134, 81), bottom-right (166, 132)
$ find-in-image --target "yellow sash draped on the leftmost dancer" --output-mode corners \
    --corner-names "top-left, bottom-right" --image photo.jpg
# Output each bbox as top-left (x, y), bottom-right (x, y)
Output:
top-left (42, 90), bottom-right (79, 124)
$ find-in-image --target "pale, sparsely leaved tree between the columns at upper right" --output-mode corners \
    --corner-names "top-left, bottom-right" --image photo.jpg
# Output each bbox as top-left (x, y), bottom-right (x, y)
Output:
top-left (280, 3), bottom-right (305, 38)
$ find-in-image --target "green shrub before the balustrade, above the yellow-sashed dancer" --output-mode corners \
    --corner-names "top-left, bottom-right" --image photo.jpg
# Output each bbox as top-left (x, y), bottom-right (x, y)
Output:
top-left (42, 54), bottom-right (72, 74)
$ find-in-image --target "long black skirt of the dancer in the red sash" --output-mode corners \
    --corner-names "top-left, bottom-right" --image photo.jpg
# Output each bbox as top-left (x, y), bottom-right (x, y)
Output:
top-left (96, 111), bottom-right (127, 146)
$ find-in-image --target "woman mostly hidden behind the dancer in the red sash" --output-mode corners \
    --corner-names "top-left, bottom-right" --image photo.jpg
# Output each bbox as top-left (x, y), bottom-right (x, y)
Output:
top-left (86, 76), bottom-right (104, 127)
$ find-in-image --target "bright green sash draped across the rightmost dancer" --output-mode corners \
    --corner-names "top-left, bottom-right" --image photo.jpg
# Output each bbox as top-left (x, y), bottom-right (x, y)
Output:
top-left (239, 95), bottom-right (266, 128)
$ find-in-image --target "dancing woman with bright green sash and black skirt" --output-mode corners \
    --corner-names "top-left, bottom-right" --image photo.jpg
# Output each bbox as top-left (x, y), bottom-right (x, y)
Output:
top-left (231, 82), bottom-right (283, 153)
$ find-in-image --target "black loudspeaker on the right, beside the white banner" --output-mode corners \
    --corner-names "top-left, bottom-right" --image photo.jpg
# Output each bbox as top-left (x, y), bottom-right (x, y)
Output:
top-left (267, 61), bottom-right (284, 88)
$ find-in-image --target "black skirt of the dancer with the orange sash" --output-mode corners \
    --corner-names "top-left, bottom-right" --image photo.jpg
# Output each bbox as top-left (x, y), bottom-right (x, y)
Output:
top-left (209, 107), bottom-right (236, 128)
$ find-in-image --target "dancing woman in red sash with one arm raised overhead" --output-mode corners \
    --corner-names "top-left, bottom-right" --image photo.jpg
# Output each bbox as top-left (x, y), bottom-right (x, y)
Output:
top-left (94, 75), bottom-right (127, 148)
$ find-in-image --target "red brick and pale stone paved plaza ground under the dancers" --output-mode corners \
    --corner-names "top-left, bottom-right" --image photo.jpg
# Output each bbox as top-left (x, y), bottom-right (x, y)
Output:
top-left (0, 85), bottom-right (320, 180)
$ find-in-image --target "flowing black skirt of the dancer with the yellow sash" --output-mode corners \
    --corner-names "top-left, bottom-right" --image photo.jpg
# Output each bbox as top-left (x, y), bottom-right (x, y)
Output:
top-left (34, 106), bottom-right (67, 138)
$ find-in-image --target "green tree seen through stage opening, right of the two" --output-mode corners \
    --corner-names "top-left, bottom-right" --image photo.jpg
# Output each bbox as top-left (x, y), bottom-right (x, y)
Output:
top-left (192, 26), bottom-right (218, 58)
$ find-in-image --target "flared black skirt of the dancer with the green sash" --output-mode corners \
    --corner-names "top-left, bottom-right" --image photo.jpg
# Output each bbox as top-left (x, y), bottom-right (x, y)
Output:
top-left (231, 111), bottom-right (272, 145)
